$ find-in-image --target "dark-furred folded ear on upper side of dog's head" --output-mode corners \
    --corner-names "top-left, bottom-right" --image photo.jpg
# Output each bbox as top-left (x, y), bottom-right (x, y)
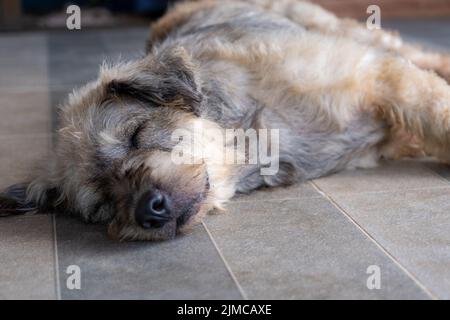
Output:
top-left (107, 48), bottom-right (202, 114)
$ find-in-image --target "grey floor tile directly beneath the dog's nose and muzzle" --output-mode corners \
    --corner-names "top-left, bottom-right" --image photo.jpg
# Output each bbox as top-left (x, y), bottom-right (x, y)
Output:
top-left (56, 217), bottom-right (241, 299)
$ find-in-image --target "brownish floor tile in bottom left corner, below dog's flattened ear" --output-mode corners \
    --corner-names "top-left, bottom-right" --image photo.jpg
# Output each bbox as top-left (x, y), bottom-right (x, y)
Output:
top-left (0, 215), bottom-right (56, 299)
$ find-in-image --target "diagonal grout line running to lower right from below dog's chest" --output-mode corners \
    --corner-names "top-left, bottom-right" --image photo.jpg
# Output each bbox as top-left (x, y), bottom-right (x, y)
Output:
top-left (309, 181), bottom-right (439, 300)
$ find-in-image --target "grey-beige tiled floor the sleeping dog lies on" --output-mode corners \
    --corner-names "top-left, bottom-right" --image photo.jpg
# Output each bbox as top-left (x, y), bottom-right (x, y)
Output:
top-left (0, 20), bottom-right (450, 299)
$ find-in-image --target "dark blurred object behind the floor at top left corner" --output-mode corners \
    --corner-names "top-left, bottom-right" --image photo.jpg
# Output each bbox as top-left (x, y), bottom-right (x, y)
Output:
top-left (0, 0), bottom-right (171, 30)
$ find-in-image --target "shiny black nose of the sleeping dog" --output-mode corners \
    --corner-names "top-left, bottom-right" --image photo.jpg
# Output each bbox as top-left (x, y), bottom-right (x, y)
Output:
top-left (135, 191), bottom-right (170, 229)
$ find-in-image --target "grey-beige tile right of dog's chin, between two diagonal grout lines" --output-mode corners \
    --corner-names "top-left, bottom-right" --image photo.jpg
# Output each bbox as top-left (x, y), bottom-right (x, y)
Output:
top-left (205, 198), bottom-right (428, 299)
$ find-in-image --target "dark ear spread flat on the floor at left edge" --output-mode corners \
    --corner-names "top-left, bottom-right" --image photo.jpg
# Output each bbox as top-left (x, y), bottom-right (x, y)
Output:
top-left (0, 180), bottom-right (61, 217)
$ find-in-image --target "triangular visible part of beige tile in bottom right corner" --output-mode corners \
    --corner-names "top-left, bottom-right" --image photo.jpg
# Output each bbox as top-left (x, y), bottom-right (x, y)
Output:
top-left (334, 187), bottom-right (450, 299)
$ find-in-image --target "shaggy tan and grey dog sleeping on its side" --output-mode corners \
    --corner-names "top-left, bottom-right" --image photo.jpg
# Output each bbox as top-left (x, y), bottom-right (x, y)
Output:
top-left (0, 0), bottom-right (450, 240)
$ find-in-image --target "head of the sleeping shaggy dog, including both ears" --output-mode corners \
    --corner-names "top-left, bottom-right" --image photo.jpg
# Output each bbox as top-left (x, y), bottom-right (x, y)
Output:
top-left (0, 49), bottom-right (234, 240)
